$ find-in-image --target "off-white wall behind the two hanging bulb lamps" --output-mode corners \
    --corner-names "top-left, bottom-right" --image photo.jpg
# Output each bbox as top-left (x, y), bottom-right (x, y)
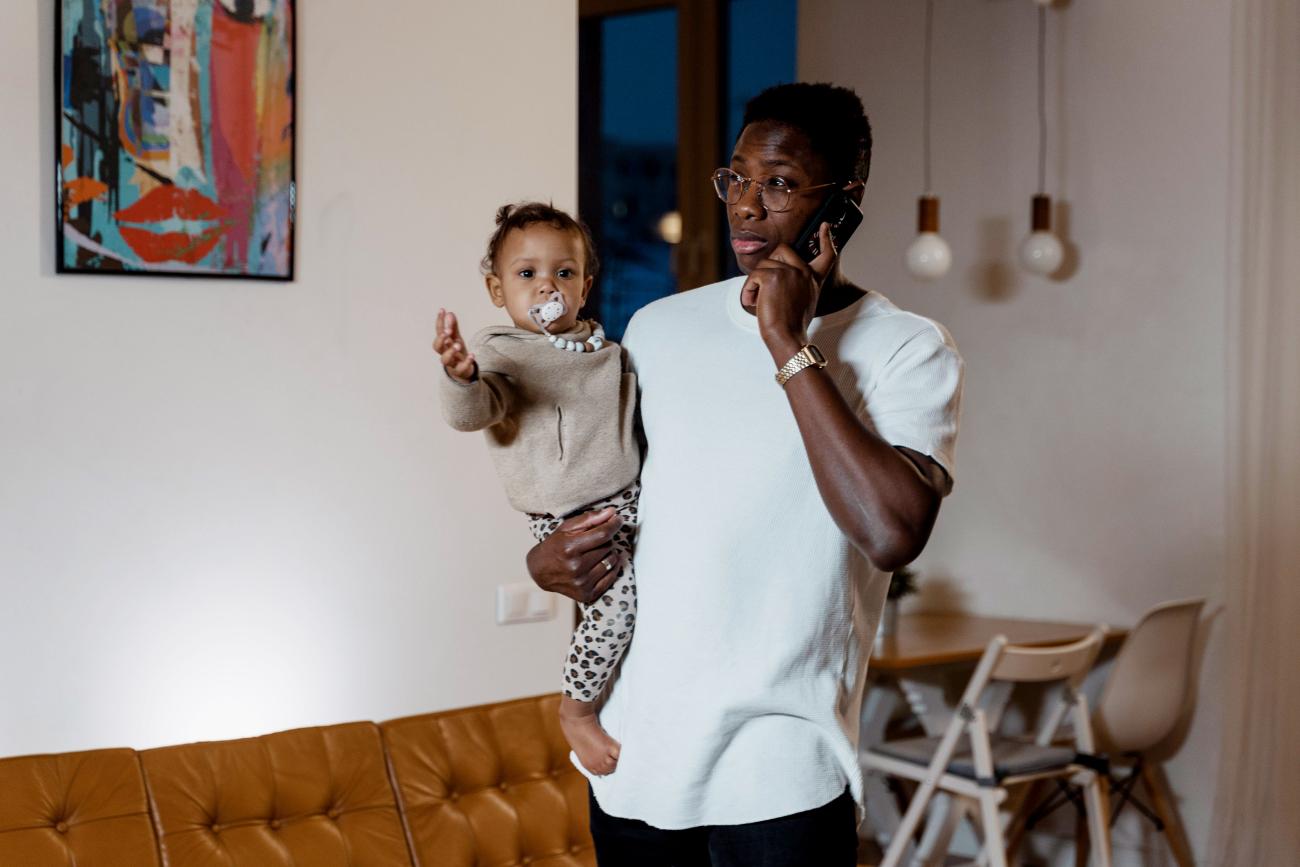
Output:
top-left (800, 0), bottom-right (1230, 864)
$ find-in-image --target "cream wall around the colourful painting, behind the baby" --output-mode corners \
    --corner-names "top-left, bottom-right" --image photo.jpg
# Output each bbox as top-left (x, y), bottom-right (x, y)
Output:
top-left (0, 0), bottom-right (577, 755)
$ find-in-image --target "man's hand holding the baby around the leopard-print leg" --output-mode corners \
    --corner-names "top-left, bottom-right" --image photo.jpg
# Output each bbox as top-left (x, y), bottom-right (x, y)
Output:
top-left (528, 506), bottom-right (623, 604)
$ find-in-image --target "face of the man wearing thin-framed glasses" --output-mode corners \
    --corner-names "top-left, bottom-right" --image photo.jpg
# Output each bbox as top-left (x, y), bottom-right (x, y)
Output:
top-left (724, 121), bottom-right (844, 274)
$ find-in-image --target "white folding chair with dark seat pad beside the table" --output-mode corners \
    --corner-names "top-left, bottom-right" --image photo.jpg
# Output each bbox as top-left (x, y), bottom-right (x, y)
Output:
top-left (862, 627), bottom-right (1110, 867)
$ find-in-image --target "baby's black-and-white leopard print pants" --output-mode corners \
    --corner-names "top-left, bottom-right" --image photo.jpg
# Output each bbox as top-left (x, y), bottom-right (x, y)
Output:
top-left (528, 482), bottom-right (641, 702)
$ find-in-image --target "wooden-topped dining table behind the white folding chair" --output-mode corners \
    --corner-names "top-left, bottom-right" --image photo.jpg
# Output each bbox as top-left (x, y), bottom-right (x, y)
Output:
top-left (859, 614), bottom-right (1127, 864)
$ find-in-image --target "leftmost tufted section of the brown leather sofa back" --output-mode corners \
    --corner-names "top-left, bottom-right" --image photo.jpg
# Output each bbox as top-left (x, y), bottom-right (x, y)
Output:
top-left (0, 750), bottom-right (159, 867)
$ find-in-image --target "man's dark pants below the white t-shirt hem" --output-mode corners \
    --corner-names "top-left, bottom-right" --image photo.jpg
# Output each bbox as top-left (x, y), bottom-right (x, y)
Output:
top-left (589, 790), bottom-right (858, 867)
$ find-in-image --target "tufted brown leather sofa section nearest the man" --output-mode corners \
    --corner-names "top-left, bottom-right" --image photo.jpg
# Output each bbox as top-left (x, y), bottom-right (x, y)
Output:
top-left (381, 695), bottom-right (595, 867)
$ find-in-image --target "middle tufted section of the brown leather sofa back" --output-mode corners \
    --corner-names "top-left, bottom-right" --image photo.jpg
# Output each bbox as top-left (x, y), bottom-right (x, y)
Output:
top-left (140, 723), bottom-right (411, 867)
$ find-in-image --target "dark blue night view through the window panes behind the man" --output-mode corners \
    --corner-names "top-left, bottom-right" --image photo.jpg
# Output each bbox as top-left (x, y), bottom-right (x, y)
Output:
top-left (580, 0), bottom-right (798, 341)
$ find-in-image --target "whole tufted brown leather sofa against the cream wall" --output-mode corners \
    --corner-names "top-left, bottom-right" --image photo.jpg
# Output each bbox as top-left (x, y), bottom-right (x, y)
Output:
top-left (0, 695), bottom-right (595, 867)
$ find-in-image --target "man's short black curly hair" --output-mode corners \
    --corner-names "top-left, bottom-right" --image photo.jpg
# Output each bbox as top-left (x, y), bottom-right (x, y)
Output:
top-left (742, 82), bottom-right (871, 182)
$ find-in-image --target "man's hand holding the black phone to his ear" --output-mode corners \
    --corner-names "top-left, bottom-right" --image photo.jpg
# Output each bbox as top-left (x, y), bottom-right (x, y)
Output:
top-left (740, 222), bottom-right (839, 365)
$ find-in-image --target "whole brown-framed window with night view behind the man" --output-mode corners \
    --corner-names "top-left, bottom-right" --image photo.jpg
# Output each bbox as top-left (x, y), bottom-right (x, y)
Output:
top-left (579, 0), bottom-right (797, 339)
